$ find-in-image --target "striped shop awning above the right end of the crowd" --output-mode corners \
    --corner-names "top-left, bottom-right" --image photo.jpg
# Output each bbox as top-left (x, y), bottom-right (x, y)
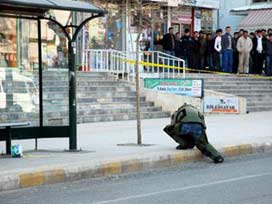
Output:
top-left (238, 9), bottom-right (272, 31)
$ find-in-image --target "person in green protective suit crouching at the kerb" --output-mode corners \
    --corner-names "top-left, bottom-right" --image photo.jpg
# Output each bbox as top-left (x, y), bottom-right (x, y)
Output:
top-left (163, 103), bottom-right (224, 163)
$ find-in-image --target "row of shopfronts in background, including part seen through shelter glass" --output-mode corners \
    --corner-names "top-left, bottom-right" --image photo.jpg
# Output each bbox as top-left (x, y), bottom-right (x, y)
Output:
top-left (0, 0), bottom-right (219, 70)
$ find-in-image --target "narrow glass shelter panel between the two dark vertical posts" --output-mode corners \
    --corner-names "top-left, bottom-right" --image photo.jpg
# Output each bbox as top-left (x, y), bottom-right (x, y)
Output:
top-left (42, 20), bottom-right (69, 126)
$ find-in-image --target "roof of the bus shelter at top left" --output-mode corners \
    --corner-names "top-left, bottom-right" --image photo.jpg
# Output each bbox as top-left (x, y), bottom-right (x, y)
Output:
top-left (0, 0), bottom-right (104, 16)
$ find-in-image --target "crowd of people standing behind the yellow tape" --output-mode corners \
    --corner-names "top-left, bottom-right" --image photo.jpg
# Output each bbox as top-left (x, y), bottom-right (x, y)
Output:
top-left (162, 26), bottom-right (272, 76)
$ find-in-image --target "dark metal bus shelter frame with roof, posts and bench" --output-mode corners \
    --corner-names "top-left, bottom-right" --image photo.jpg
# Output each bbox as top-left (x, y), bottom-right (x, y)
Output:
top-left (0, 0), bottom-right (105, 153)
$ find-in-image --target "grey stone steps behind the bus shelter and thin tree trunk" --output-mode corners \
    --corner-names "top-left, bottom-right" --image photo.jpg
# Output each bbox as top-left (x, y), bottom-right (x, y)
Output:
top-left (44, 71), bottom-right (169, 124)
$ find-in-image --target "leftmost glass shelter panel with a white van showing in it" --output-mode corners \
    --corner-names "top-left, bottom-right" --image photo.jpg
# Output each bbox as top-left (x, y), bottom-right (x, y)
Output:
top-left (0, 17), bottom-right (39, 126)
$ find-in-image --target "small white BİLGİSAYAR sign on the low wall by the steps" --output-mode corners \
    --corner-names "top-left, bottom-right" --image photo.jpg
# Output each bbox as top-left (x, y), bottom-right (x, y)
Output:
top-left (204, 97), bottom-right (239, 113)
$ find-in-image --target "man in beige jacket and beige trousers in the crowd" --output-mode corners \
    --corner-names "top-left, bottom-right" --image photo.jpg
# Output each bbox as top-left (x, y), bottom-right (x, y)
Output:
top-left (236, 30), bottom-right (253, 74)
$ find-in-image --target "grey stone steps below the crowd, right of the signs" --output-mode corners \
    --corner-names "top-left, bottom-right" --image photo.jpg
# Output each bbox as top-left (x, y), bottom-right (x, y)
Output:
top-left (186, 74), bottom-right (272, 112)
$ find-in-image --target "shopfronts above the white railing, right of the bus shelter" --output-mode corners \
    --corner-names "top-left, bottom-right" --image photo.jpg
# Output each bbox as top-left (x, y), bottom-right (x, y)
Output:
top-left (86, 0), bottom-right (219, 51)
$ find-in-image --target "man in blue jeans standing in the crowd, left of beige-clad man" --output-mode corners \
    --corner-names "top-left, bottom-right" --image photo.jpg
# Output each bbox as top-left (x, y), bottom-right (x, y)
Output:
top-left (222, 26), bottom-right (233, 72)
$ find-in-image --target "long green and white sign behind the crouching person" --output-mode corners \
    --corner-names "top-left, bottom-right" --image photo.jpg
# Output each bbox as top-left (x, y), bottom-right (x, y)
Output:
top-left (144, 78), bottom-right (203, 98)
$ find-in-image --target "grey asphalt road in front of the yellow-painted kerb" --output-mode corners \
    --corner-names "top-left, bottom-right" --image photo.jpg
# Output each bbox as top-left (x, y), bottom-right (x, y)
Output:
top-left (0, 153), bottom-right (272, 204)
